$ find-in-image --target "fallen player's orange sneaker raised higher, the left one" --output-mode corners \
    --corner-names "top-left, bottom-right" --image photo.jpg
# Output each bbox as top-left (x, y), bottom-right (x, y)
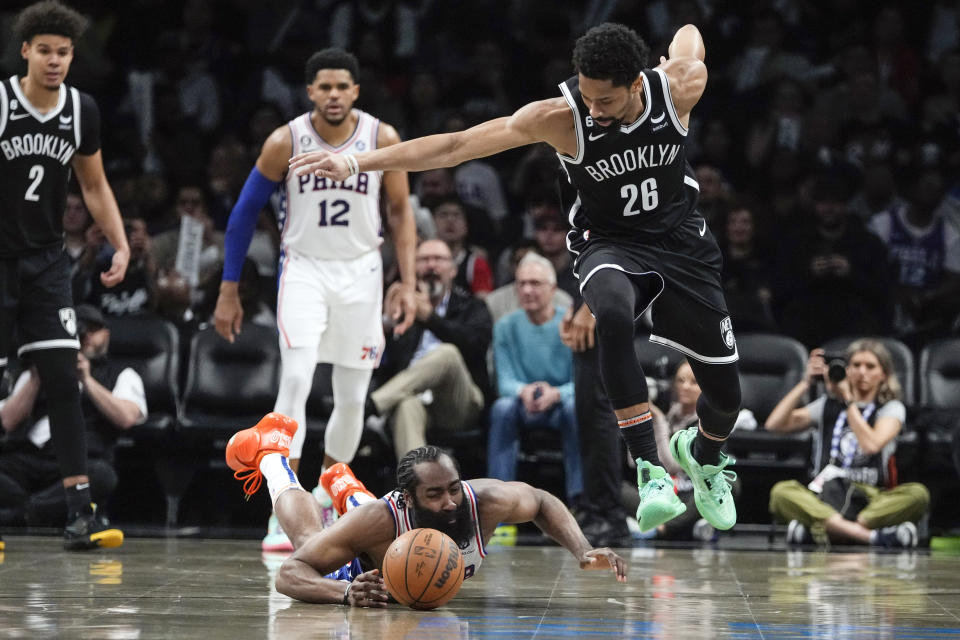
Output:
top-left (225, 412), bottom-right (297, 498)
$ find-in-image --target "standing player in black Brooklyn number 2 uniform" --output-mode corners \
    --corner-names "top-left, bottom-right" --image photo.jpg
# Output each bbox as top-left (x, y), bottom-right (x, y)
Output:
top-left (0, 1), bottom-right (130, 550)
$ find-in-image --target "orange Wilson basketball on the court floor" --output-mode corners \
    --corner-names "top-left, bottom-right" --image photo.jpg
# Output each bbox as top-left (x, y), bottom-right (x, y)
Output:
top-left (383, 529), bottom-right (463, 609)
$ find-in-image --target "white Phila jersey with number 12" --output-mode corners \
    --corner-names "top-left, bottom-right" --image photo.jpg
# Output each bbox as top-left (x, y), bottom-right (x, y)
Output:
top-left (279, 109), bottom-right (383, 260)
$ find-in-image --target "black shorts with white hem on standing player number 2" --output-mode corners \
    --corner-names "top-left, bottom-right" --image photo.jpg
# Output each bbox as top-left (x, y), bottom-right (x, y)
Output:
top-left (0, 247), bottom-right (80, 366)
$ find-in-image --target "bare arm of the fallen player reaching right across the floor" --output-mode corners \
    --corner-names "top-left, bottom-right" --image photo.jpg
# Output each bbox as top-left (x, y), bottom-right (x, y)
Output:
top-left (470, 478), bottom-right (627, 582)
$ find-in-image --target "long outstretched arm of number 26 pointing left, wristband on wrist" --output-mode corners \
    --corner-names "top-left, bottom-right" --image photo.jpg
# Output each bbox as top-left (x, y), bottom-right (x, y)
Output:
top-left (290, 98), bottom-right (576, 180)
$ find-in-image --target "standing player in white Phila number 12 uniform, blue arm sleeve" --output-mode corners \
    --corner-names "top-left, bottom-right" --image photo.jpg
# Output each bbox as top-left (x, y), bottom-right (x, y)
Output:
top-left (214, 49), bottom-right (416, 550)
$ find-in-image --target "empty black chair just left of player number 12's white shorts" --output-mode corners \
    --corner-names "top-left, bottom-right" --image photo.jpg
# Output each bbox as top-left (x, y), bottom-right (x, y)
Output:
top-left (180, 324), bottom-right (280, 439)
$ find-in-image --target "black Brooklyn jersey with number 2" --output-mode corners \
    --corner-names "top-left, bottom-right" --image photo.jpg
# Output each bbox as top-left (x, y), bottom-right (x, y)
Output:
top-left (0, 76), bottom-right (100, 258)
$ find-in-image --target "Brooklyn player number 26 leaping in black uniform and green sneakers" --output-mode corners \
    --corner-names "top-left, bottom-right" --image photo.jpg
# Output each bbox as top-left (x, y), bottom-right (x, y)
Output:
top-left (291, 23), bottom-right (740, 531)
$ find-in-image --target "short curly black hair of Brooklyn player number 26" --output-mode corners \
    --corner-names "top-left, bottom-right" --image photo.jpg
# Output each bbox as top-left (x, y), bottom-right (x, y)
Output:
top-left (573, 22), bottom-right (650, 87)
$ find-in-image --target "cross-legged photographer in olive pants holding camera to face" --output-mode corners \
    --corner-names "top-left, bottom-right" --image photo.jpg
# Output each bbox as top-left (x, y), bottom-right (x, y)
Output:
top-left (764, 339), bottom-right (930, 547)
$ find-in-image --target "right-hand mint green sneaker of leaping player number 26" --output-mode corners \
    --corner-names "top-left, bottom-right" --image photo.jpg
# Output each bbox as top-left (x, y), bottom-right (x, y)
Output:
top-left (670, 425), bottom-right (737, 531)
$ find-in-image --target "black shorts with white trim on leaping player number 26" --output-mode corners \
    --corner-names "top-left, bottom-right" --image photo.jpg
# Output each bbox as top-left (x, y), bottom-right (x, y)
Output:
top-left (570, 214), bottom-right (738, 364)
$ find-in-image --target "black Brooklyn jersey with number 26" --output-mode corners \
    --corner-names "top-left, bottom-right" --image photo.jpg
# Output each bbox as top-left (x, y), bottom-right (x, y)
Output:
top-left (557, 69), bottom-right (699, 242)
